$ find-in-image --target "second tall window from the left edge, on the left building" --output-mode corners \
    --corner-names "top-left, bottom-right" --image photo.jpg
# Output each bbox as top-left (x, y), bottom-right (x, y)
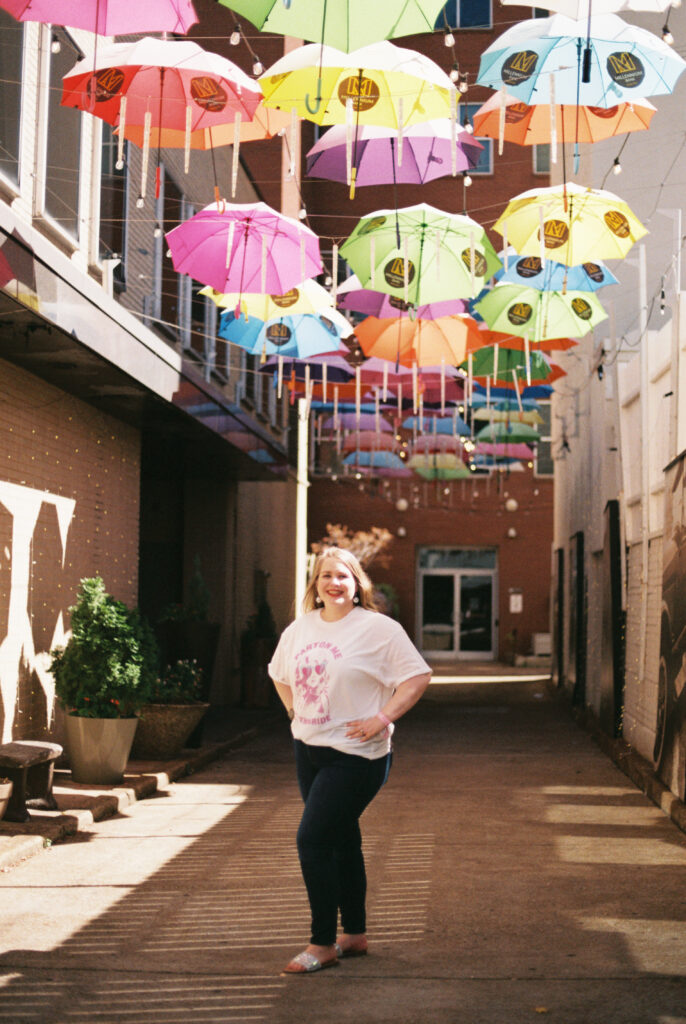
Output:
top-left (44, 27), bottom-right (83, 239)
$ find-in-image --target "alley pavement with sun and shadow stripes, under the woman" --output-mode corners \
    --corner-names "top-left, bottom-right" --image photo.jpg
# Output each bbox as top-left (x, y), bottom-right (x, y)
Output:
top-left (0, 677), bottom-right (686, 1024)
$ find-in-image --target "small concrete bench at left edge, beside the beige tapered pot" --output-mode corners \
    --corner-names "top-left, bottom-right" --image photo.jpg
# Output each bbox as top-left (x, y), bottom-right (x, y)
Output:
top-left (0, 739), bottom-right (61, 821)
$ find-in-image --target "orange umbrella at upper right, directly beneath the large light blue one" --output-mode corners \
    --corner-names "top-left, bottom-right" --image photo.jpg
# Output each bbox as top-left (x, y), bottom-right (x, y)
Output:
top-left (472, 93), bottom-right (656, 145)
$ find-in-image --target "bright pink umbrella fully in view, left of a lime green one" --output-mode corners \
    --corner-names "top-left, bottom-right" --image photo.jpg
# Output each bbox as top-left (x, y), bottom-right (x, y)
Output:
top-left (166, 202), bottom-right (324, 295)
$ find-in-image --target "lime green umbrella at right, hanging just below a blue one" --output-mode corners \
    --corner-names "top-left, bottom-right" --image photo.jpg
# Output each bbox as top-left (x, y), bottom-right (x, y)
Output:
top-left (476, 285), bottom-right (607, 341)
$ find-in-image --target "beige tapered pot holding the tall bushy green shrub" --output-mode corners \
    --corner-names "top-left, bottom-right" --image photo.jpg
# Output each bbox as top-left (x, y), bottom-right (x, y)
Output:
top-left (67, 715), bottom-right (138, 785)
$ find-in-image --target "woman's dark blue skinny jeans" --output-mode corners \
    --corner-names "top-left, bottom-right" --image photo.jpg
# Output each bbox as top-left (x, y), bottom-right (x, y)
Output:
top-left (294, 739), bottom-right (391, 946)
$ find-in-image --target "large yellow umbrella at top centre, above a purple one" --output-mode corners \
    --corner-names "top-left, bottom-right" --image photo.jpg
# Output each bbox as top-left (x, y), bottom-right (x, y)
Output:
top-left (259, 42), bottom-right (457, 128)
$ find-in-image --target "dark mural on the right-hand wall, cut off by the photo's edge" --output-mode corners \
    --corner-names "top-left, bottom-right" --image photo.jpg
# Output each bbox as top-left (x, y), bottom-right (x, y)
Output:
top-left (653, 452), bottom-right (686, 800)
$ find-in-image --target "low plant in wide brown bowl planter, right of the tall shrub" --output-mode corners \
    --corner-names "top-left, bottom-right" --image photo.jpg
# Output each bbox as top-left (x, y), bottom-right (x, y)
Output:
top-left (131, 658), bottom-right (210, 761)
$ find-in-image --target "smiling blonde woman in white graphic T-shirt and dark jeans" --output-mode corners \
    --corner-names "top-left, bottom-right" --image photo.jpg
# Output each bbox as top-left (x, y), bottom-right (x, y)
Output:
top-left (269, 548), bottom-right (431, 974)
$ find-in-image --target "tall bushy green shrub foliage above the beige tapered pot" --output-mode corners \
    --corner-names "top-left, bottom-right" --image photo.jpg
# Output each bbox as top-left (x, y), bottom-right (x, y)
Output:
top-left (50, 577), bottom-right (159, 718)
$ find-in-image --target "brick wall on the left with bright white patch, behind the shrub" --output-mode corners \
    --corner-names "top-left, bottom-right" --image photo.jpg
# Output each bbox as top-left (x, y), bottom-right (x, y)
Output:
top-left (0, 360), bottom-right (139, 741)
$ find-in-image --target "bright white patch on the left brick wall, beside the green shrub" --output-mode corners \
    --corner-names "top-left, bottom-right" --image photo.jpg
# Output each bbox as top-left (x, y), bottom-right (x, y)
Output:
top-left (0, 481), bottom-right (76, 742)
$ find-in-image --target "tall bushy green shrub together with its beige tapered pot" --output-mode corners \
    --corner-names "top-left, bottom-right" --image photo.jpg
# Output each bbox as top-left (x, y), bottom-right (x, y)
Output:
top-left (50, 577), bottom-right (159, 784)
